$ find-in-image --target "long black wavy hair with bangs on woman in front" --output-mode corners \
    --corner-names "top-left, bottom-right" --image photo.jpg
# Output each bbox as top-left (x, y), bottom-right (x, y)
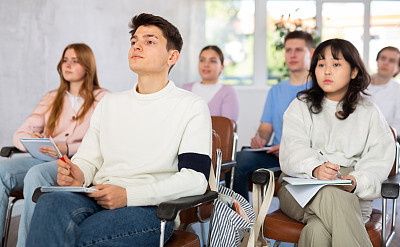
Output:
top-left (297, 39), bottom-right (371, 120)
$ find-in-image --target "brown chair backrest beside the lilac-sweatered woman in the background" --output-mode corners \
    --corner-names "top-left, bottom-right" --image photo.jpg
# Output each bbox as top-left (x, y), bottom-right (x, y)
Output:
top-left (211, 116), bottom-right (237, 162)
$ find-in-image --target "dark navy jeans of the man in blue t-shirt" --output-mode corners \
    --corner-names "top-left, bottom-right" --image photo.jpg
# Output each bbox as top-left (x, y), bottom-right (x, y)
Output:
top-left (225, 151), bottom-right (279, 200)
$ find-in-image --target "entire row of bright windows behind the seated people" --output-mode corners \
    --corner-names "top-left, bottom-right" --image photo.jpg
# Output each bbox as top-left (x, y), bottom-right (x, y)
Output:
top-left (206, 0), bottom-right (400, 86)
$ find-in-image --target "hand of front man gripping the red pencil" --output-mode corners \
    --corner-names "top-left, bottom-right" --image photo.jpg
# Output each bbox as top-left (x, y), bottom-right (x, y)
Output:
top-left (57, 155), bottom-right (85, 186)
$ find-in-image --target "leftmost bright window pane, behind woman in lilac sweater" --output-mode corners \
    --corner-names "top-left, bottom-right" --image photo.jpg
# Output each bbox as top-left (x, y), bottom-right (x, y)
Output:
top-left (206, 0), bottom-right (254, 85)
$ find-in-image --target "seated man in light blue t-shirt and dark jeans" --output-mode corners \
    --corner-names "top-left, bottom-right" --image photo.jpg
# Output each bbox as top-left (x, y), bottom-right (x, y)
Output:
top-left (231, 31), bottom-right (314, 199)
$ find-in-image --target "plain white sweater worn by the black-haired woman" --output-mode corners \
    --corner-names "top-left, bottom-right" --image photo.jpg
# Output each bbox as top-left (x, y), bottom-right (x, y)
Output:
top-left (279, 98), bottom-right (395, 221)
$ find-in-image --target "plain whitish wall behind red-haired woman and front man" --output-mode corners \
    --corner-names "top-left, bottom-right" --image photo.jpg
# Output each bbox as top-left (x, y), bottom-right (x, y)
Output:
top-left (0, 0), bottom-right (205, 149)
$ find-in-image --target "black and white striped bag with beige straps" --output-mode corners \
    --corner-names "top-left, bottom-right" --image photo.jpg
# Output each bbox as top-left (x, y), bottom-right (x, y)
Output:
top-left (210, 169), bottom-right (275, 247)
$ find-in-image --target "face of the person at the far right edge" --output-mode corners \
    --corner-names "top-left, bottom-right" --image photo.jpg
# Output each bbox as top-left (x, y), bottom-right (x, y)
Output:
top-left (377, 50), bottom-right (400, 77)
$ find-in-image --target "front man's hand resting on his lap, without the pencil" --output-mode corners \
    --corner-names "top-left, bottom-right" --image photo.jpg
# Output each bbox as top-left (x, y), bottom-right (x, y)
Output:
top-left (88, 184), bottom-right (128, 209)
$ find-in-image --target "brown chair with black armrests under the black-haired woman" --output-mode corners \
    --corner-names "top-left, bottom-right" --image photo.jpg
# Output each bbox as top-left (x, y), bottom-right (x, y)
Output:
top-left (252, 128), bottom-right (400, 247)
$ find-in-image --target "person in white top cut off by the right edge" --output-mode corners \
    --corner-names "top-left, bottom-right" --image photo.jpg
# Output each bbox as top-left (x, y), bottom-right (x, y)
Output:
top-left (366, 46), bottom-right (400, 139)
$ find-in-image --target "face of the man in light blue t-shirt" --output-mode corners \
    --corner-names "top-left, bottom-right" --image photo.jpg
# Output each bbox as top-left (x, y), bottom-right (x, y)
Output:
top-left (285, 39), bottom-right (312, 72)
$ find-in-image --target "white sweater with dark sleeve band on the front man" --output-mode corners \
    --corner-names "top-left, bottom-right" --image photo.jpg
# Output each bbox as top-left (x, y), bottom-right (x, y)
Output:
top-left (72, 81), bottom-right (212, 206)
